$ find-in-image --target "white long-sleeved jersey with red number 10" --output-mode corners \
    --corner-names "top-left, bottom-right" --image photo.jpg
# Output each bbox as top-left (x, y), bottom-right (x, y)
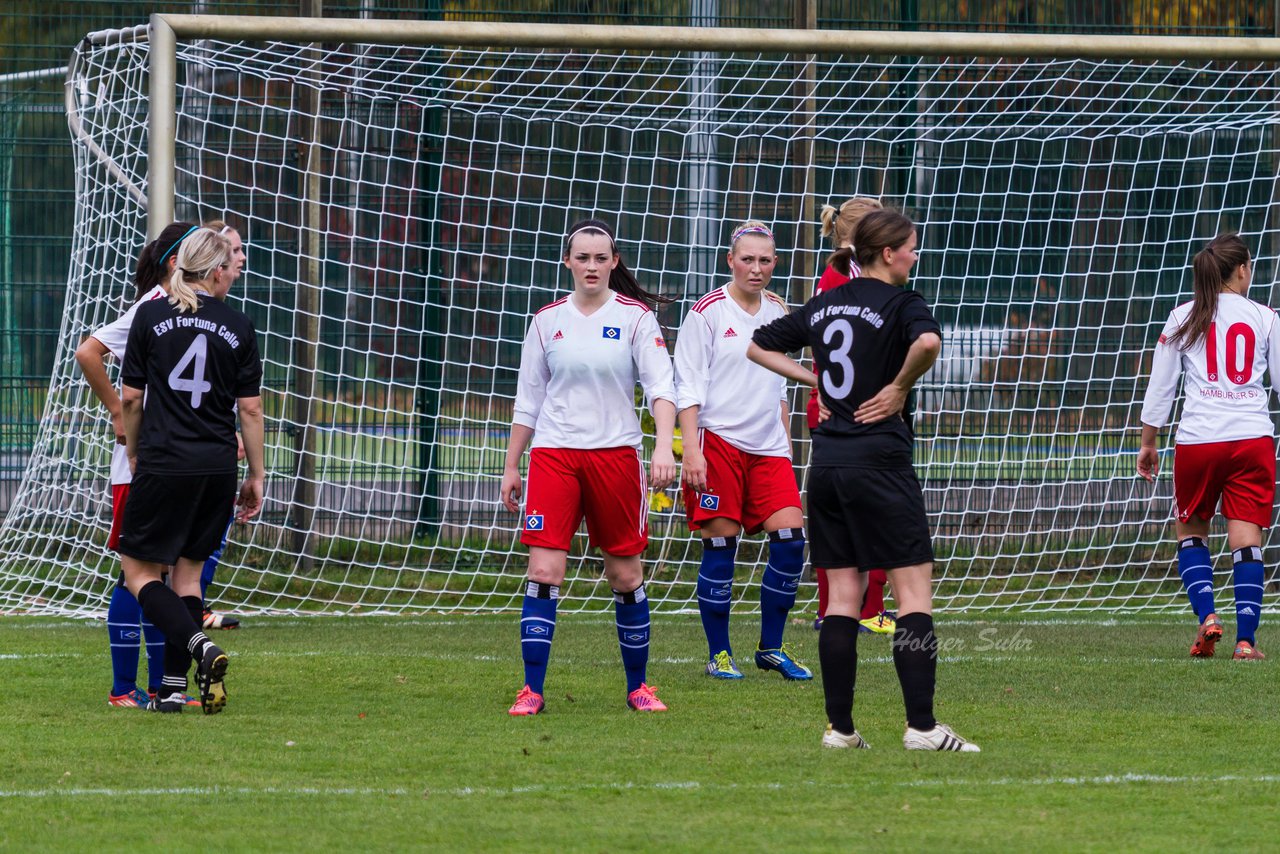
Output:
top-left (1142, 293), bottom-right (1280, 444)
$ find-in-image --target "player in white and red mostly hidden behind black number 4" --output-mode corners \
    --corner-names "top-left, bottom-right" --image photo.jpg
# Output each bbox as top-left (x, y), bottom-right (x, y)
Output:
top-left (76, 223), bottom-right (198, 708)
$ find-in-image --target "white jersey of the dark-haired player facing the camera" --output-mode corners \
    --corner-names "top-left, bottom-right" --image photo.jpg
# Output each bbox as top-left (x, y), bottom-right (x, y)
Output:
top-left (513, 291), bottom-right (676, 448)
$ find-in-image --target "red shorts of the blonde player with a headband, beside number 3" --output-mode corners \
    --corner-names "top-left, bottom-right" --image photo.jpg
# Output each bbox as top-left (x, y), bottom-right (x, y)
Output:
top-left (684, 430), bottom-right (800, 534)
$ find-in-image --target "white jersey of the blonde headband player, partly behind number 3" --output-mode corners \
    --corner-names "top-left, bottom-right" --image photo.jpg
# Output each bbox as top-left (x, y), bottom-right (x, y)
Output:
top-left (676, 286), bottom-right (791, 458)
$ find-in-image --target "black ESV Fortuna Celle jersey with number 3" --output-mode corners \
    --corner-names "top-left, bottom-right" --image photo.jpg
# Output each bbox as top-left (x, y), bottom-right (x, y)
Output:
top-left (751, 278), bottom-right (942, 467)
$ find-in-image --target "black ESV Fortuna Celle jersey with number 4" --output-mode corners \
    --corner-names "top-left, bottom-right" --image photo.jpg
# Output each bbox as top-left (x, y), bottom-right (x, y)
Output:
top-left (120, 293), bottom-right (262, 475)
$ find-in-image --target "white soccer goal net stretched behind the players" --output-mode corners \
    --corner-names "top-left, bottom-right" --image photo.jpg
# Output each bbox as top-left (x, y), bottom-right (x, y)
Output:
top-left (0, 18), bottom-right (1280, 613)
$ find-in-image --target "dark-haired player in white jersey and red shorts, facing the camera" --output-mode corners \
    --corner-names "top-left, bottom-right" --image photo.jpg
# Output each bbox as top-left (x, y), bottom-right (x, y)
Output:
top-left (500, 219), bottom-right (676, 714)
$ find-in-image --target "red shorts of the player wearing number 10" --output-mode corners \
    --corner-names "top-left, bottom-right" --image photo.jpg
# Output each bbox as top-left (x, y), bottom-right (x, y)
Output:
top-left (1174, 437), bottom-right (1276, 528)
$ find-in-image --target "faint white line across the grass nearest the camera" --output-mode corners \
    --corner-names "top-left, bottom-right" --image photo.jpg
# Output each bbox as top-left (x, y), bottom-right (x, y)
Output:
top-left (0, 773), bottom-right (1280, 800)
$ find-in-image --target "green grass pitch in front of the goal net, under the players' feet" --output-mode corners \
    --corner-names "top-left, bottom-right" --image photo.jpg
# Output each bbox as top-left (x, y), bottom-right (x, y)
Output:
top-left (0, 615), bottom-right (1280, 851)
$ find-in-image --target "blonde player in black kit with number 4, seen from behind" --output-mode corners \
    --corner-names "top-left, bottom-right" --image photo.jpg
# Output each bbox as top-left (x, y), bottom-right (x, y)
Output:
top-left (118, 228), bottom-right (264, 714)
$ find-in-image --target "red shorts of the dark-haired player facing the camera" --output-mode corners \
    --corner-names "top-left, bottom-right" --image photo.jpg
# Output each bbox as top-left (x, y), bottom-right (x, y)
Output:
top-left (520, 448), bottom-right (649, 557)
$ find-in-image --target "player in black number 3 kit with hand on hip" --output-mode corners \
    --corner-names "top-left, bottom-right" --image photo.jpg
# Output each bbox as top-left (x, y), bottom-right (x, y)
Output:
top-left (748, 210), bottom-right (978, 752)
